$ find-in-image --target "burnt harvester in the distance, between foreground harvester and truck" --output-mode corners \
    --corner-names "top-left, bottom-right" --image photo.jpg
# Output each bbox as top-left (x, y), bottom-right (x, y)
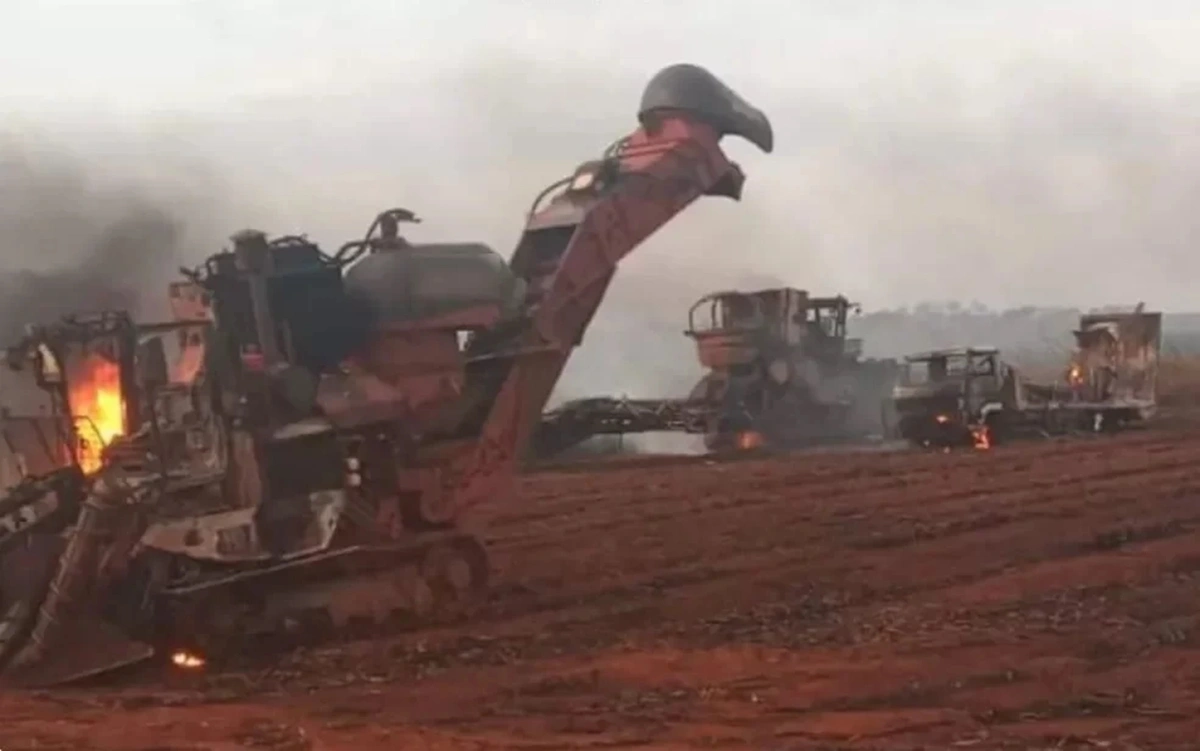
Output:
top-left (535, 288), bottom-right (899, 455)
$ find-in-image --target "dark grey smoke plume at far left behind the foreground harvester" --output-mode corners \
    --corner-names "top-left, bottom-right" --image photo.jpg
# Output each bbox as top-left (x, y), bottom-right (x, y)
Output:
top-left (0, 138), bottom-right (232, 344)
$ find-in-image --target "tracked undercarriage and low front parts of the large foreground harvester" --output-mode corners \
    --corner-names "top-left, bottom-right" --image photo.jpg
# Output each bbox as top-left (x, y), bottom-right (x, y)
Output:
top-left (0, 455), bottom-right (488, 685)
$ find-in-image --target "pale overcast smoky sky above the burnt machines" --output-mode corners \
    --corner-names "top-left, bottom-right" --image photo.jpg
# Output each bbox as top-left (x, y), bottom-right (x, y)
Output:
top-left (0, 0), bottom-right (1200, 320)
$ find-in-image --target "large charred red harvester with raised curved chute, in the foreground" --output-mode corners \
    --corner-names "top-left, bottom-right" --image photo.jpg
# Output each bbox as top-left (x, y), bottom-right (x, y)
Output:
top-left (0, 65), bottom-right (773, 684)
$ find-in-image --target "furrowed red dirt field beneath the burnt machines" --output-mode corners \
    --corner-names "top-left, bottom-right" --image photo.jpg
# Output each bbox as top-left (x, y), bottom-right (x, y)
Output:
top-left (0, 431), bottom-right (1200, 751)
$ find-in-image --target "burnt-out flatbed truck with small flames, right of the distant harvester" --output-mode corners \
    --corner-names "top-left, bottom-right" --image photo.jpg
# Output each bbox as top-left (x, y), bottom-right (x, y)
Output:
top-left (889, 305), bottom-right (1163, 449)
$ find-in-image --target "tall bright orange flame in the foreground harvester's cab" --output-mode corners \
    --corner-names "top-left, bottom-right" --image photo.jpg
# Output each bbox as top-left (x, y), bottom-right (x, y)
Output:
top-left (67, 355), bottom-right (125, 474)
